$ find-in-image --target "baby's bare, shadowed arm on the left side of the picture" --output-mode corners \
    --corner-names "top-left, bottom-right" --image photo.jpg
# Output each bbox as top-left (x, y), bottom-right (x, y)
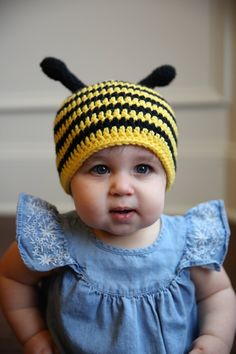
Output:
top-left (0, 242), bottom-right (56, 354)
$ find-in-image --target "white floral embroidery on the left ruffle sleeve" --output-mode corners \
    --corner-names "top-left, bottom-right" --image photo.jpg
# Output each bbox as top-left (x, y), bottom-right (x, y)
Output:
top-left (20, 195), bottom-right (70, 268)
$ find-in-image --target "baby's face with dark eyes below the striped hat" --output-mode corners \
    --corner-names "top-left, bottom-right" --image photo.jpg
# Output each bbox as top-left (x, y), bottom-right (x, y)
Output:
top-left (71, 145), bottom-right (166, 242)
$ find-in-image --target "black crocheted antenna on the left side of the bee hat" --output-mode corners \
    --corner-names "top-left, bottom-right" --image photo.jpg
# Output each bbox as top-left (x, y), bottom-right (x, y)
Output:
top-left (40, 57), bottom-right (86, 92)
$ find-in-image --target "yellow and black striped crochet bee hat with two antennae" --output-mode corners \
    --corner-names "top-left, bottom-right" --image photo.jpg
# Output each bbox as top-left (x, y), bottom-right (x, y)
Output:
top-left (40, 57), bottom-right (178, 194)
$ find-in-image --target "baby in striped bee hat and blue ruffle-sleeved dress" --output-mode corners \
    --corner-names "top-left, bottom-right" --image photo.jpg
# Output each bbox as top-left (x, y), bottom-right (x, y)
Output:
top-left (0, 58), bottom-right (236, 354)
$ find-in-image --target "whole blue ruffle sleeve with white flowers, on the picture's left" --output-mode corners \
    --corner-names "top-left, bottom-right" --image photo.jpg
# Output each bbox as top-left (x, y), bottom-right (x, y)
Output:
top-left (16, 193), bottom-right (74, 271)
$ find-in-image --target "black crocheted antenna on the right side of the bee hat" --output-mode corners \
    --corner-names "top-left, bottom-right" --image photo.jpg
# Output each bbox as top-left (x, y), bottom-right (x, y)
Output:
top-left (139, 65), bottom-right (176, 88)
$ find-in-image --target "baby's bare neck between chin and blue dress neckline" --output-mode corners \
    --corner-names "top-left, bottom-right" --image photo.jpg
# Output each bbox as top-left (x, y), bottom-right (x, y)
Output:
top-left (93, 219), bottom-right (161, 249)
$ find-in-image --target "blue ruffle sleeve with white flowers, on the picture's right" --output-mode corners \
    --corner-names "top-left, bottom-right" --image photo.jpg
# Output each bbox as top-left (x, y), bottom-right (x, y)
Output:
top-left (179, 200), bottom-right (230, 271)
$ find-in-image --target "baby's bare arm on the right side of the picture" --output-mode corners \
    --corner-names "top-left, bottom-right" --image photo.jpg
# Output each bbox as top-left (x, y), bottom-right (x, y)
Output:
top-left (190, 267), bottom-right (236, 354)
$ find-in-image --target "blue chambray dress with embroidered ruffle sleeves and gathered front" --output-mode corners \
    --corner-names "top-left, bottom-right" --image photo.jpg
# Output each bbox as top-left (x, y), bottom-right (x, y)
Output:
top-left (17, 194), bottom-right (229, 354)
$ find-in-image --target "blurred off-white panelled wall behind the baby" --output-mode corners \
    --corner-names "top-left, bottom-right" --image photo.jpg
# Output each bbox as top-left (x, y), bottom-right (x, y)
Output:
top-left (0, 0), bottom-right (235, 215)
